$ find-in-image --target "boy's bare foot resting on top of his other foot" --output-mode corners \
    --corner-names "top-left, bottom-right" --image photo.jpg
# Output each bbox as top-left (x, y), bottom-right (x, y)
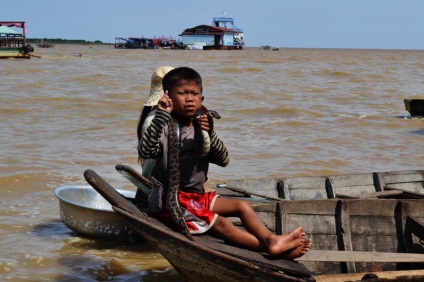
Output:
top-left (268, 226), bottom-right (306, 256)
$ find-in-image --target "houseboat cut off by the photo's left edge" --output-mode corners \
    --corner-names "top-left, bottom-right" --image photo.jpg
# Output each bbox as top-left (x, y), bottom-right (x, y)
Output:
top-left (0, 22), bottom-right (34, 59)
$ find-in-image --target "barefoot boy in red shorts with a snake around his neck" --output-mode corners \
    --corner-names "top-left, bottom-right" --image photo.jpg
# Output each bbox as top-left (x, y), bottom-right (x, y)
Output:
top-left (138, 67), bottom-right (312, 259)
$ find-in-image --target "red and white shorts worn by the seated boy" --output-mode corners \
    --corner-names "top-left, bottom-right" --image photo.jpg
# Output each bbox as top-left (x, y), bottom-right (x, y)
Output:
top-left (154, 191), bottom-right (219, 234)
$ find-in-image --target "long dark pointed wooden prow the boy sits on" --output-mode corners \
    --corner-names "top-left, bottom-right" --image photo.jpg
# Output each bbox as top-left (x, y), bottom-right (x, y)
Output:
top-left (84, 170), bottom-right (315, 281)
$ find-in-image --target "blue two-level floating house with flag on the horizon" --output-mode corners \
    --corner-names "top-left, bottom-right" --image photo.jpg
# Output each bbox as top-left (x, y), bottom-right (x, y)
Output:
top-left (180, 17), bottom-right (244, 50)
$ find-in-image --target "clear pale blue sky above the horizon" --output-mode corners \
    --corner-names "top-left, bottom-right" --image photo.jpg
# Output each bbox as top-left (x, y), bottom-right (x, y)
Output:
top-left (0, 0), bottom-right (424, 49)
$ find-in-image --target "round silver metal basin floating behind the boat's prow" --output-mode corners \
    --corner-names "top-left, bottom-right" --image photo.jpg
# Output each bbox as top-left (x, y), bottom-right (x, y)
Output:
top-left (53, 185), bottom-right (138, 238)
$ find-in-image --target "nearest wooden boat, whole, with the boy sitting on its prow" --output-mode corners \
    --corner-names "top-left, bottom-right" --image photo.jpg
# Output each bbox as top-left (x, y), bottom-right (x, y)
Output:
top-left (84, 170), bottom-right (424, 281)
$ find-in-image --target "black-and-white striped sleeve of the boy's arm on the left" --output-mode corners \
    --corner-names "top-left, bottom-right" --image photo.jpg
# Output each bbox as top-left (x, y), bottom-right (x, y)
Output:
top-left (137, 110), bottom-right (171, 159)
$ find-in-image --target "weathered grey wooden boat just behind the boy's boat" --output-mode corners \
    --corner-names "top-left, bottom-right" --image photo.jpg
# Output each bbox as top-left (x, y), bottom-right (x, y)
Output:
top-left (222, 170), bottom-right (424, 200)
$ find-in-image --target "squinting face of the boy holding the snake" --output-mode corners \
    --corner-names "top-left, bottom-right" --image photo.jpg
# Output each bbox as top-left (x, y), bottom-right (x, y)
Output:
top-left (169, 80), bottom-right (204, 118)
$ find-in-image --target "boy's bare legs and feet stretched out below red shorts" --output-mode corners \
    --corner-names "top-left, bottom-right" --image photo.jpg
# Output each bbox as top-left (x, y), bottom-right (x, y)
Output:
top-left (212, 198), bottom-right (305, 255)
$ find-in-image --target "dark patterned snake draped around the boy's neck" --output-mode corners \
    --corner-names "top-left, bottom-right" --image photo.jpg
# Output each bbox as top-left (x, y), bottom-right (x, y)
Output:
top-left (166, 108), bottom-right (221, 241)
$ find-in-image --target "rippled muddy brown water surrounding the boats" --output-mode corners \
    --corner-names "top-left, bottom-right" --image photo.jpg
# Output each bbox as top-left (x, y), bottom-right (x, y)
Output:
top-left (0, 45), bottom-right (424, 281)
